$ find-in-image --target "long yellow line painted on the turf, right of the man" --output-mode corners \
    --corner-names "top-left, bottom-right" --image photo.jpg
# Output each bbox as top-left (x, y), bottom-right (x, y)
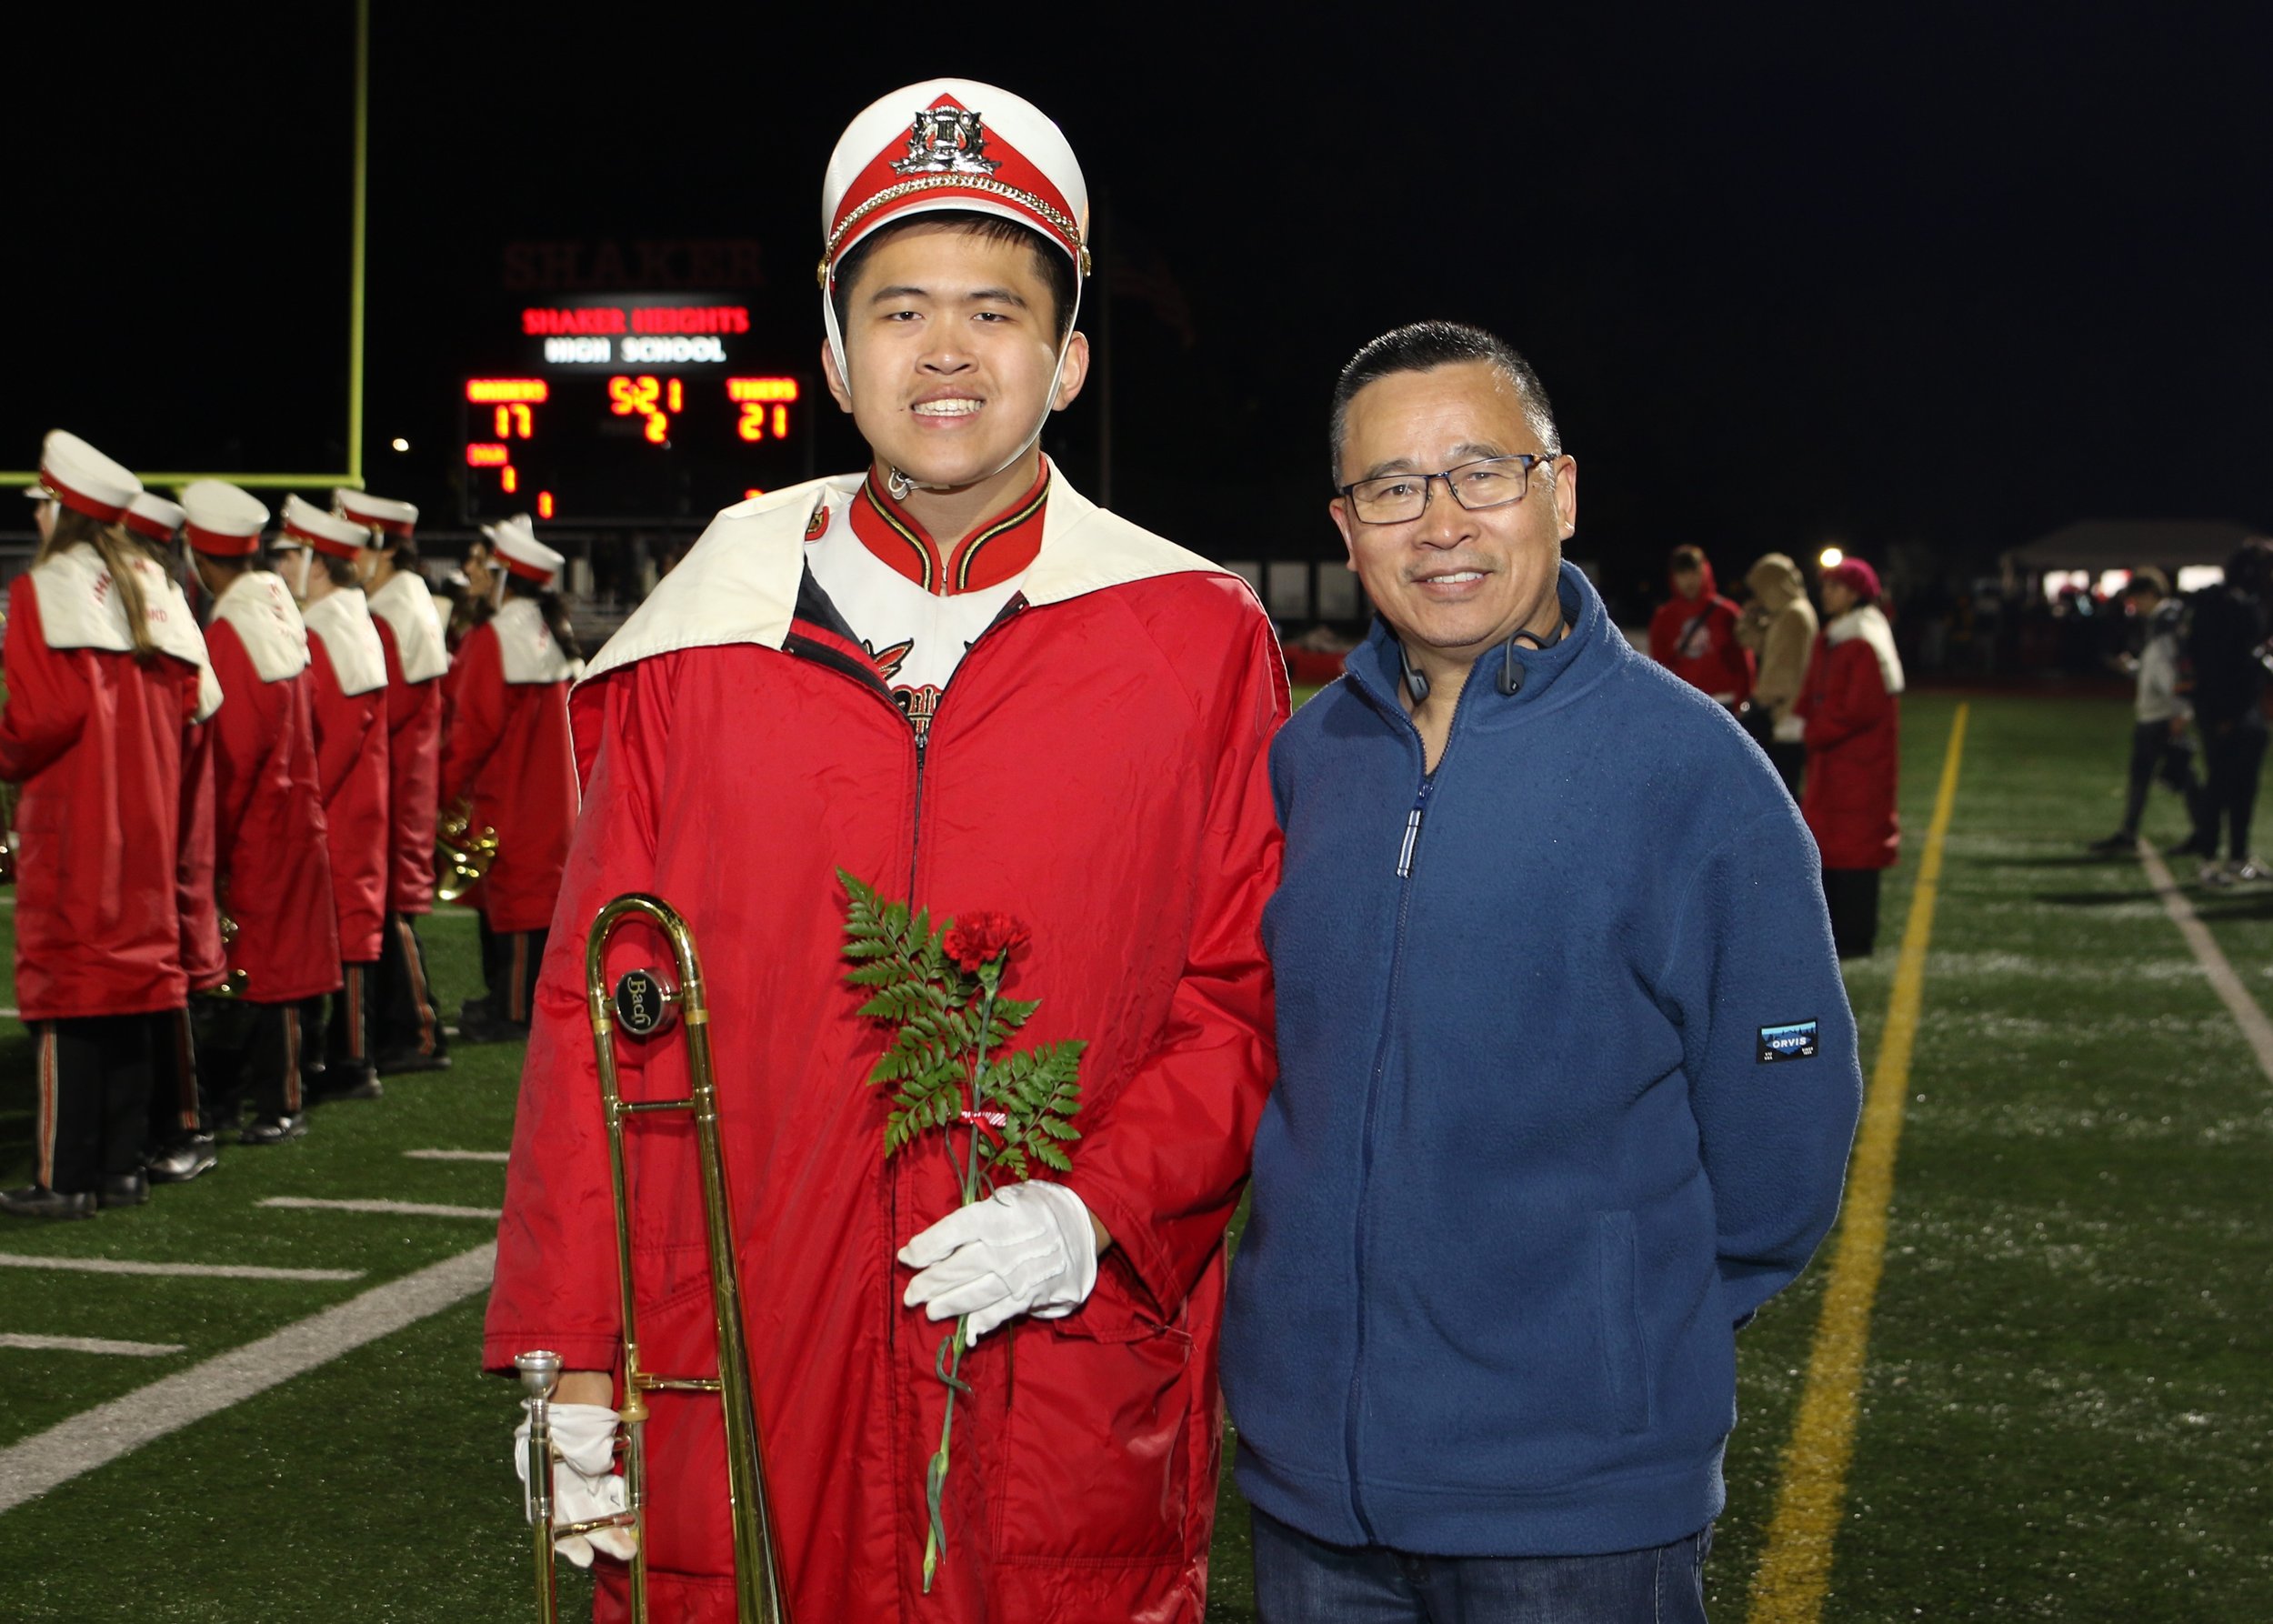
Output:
top-left (1750, 703), bottom-right (1968, 1624)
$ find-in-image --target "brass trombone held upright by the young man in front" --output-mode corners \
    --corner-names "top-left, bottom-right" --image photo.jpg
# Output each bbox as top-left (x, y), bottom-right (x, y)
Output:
top-left (514, 892), bottom-right (789, 1624)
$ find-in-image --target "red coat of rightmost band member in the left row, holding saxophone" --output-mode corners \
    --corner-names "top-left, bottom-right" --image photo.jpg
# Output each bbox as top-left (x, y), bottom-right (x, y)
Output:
top-left (427, 598), bottom-right (577, 933)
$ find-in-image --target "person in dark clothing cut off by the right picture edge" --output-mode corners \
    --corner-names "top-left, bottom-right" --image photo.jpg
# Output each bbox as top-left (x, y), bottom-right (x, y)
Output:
top-left (2187, 539), bottom-right (2273, 885)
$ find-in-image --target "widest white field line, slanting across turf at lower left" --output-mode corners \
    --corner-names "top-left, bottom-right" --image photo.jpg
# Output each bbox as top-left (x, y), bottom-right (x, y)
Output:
top-left (0, 1244), bottom-right (498, 1512)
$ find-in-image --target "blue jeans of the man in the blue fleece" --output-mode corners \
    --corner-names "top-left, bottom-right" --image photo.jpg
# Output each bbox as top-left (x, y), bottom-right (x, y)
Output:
top-left (1255, 1510), bottom-right (1712, 1624)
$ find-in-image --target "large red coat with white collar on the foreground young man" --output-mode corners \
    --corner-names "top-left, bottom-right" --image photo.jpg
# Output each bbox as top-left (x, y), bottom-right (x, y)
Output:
top-left (485, 477), bottom-right (1287, 1624)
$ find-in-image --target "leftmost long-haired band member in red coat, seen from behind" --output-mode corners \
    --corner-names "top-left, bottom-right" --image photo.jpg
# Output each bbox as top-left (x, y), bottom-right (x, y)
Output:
top-left (0, 430), bottom-right (212, 1219)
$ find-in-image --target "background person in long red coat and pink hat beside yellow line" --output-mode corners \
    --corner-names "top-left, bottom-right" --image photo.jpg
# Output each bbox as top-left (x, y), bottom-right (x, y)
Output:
top-left (1791, 557), bottom-right (1903, 957)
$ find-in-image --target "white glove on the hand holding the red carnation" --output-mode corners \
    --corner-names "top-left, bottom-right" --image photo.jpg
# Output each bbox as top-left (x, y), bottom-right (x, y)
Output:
top-left (900, 1183), bottom-right (1098, 1342)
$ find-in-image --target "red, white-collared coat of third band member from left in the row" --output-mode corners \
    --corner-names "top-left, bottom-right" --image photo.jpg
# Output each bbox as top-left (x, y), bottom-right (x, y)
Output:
top-left (205, 568), bottom-right (341, 1003)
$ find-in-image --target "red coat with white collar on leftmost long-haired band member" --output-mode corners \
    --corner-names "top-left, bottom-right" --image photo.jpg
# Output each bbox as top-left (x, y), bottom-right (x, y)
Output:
top-left (0, 544), bottom-right (221, 1021)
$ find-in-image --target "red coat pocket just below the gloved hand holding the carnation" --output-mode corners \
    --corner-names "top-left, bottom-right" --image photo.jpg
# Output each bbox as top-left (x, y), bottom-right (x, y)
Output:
top-left (991, 1274), bottom-right (1214, 1565)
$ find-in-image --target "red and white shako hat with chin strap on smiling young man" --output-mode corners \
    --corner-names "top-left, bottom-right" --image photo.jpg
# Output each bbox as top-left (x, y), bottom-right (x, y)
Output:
top-left (821, 80), bottom-right (1089, 468)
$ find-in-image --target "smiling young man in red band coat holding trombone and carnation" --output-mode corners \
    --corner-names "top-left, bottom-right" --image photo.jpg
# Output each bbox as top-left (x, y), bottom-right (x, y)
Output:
top-left (485, 80), bottom-right (1287, 1624)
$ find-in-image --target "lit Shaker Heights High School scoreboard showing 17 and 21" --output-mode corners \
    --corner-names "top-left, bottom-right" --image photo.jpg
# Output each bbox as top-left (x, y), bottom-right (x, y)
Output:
top-left (459, 294), bottom-right (816, 523)
